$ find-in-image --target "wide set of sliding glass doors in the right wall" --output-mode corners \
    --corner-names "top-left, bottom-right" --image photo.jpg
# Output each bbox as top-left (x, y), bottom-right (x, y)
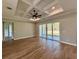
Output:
top-left (39, 22), bottom-right (60, 41)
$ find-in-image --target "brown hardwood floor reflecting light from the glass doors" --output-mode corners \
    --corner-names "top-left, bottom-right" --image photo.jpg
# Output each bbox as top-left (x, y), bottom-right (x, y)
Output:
top-left (2, 38), bottom-right (77, 59)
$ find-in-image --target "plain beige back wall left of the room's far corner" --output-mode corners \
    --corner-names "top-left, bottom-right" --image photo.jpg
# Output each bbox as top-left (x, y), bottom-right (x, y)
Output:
top-left (14, 22), bottom-right (34, 40)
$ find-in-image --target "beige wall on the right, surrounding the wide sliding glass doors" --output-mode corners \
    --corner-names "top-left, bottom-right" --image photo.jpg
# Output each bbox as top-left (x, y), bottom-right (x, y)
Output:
top-left (40, 13), bottom-right (77, 45)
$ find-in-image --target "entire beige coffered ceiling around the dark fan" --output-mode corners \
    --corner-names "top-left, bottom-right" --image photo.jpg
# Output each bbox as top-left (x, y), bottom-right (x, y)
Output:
top-left (2, 0), bottom-right (77, 21)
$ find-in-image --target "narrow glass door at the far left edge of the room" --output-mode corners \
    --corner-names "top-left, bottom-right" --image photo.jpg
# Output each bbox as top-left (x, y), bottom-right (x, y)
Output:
top-left (3, 22), bottom-right (13, 40)
